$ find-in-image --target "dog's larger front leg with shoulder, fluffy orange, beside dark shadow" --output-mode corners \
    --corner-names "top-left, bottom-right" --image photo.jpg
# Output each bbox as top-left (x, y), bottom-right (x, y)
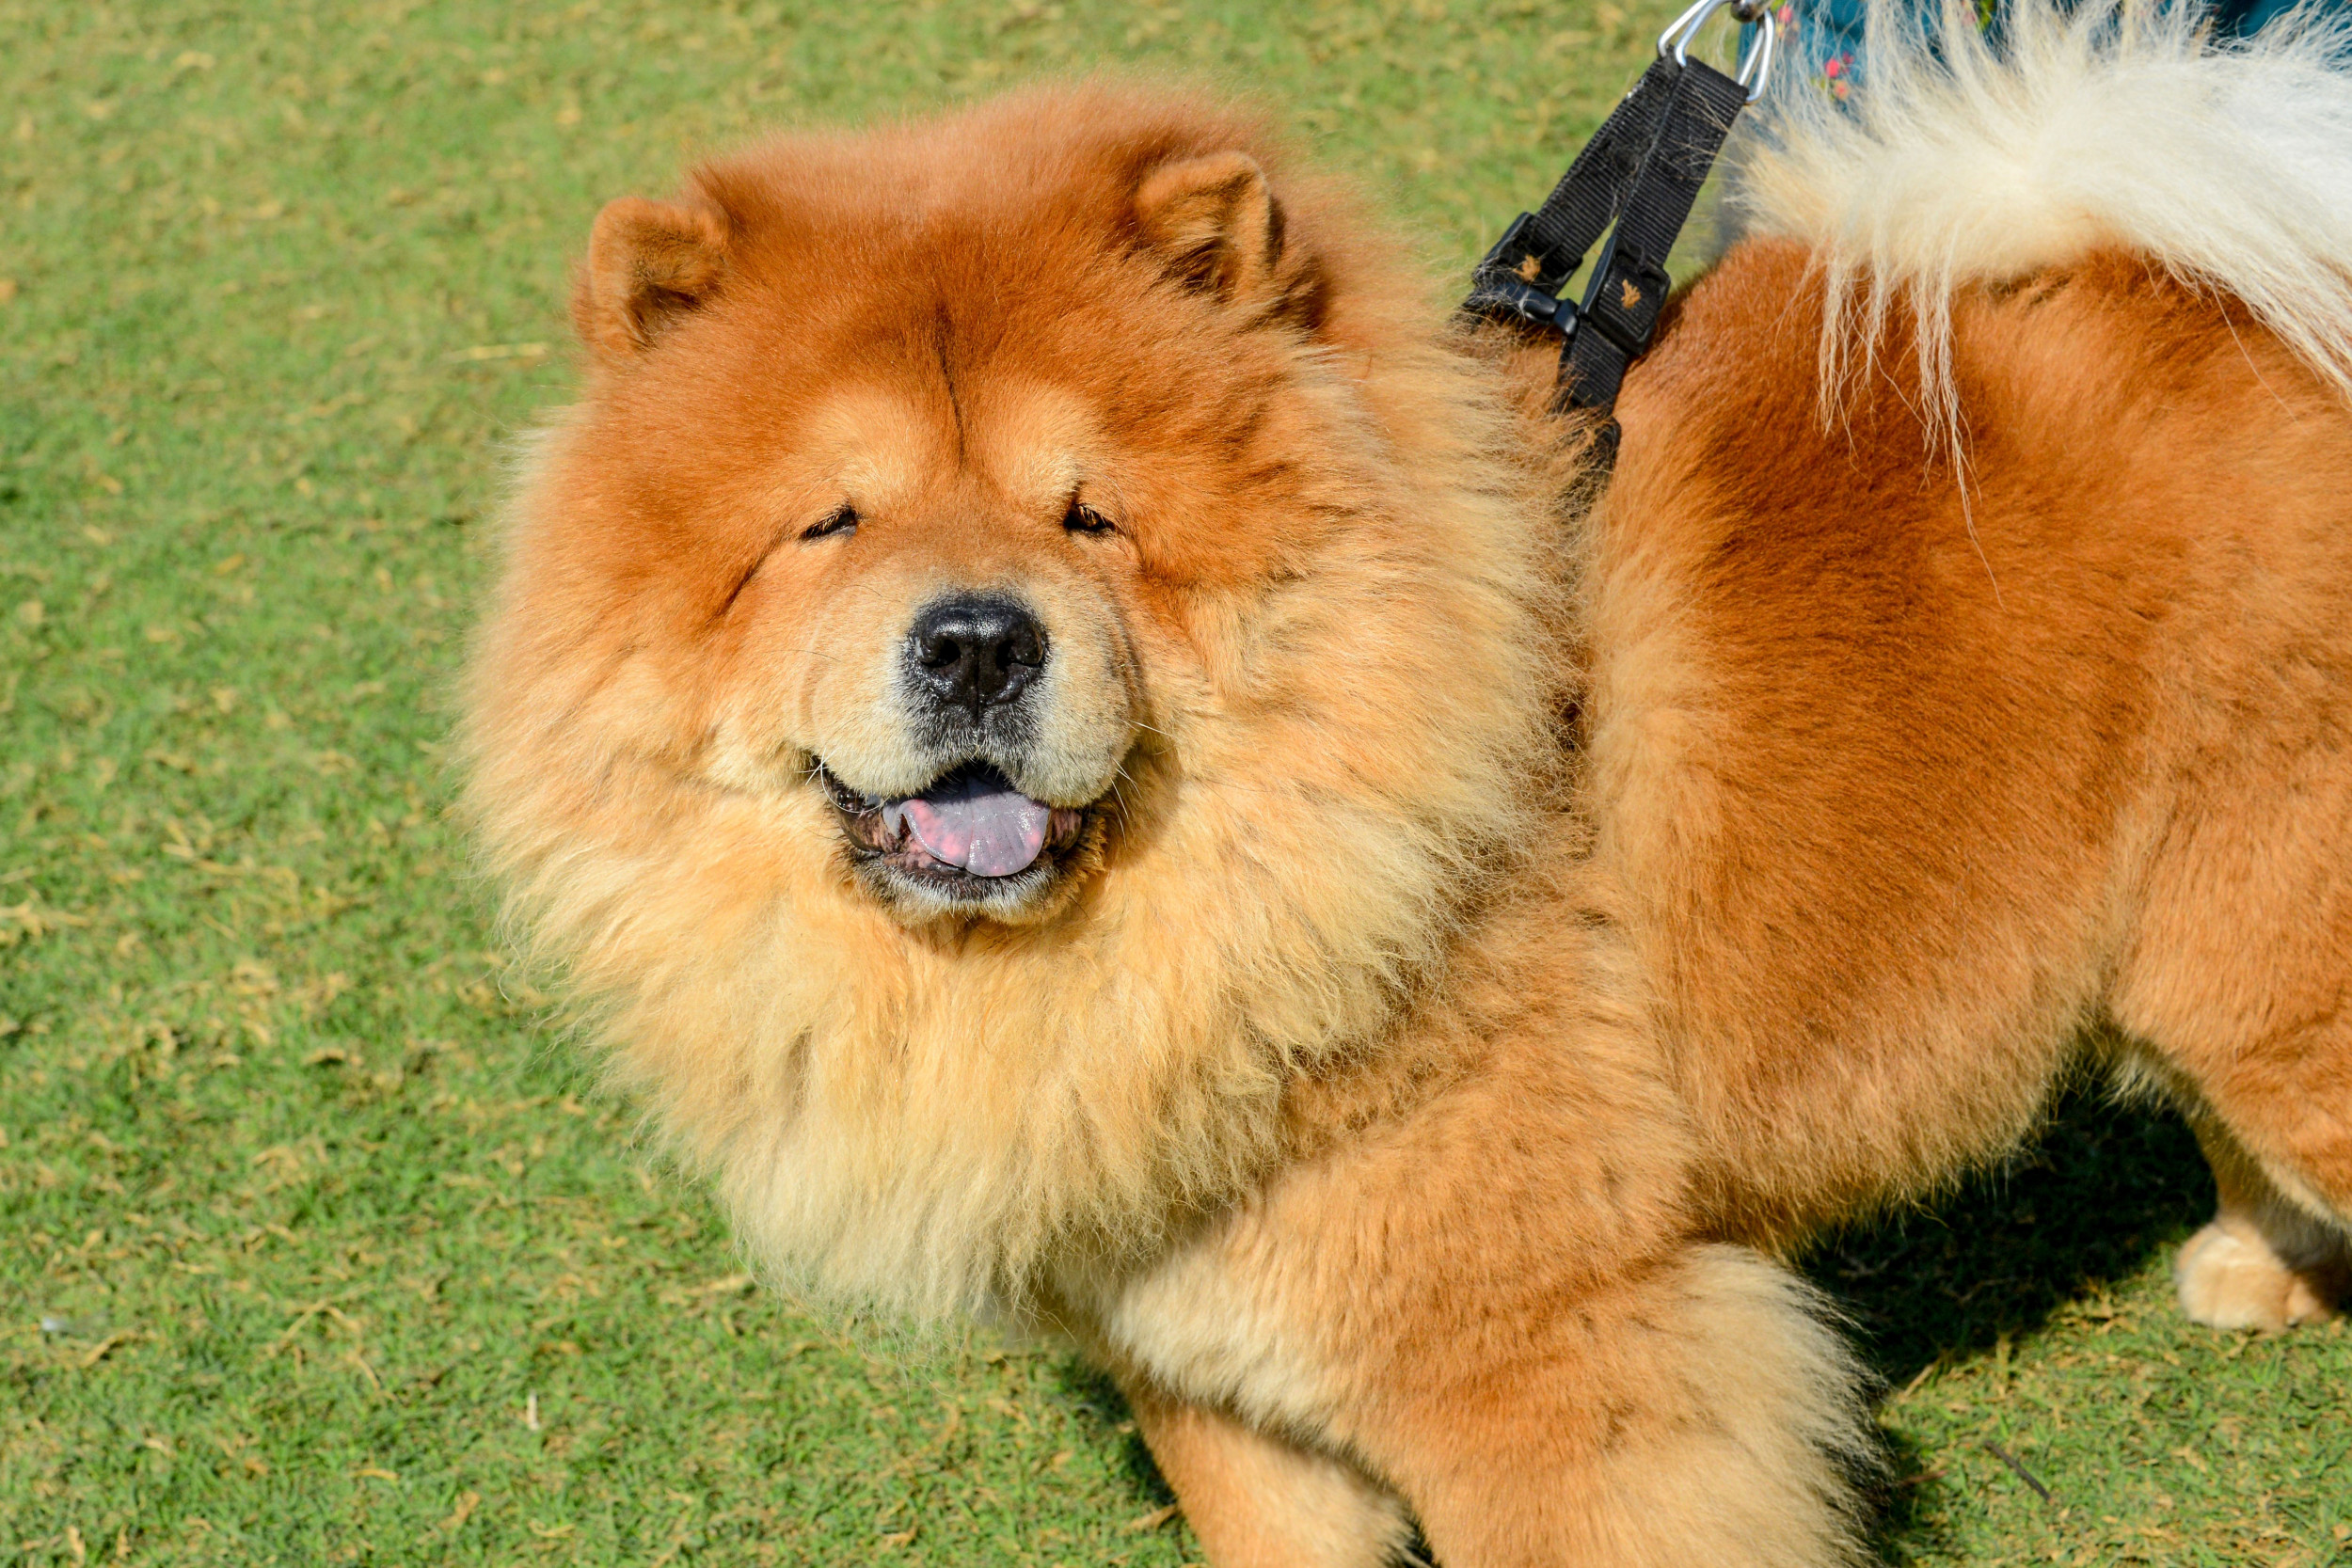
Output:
top-left (1071, 905), bottom-right (1875, 1568)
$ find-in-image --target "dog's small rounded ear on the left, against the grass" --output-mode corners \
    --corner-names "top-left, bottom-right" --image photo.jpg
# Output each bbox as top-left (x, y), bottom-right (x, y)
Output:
top-left (572, 195), bottom-right (727, 362)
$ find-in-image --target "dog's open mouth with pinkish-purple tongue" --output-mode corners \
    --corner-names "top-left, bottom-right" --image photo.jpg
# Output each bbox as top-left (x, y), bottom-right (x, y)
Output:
top-left (817, 762), bottom-right (1087, 894)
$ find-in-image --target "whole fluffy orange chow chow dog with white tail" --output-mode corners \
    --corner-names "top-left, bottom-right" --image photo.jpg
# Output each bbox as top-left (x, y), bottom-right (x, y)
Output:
top-left (464, 7), bottom-right (2352, 1568)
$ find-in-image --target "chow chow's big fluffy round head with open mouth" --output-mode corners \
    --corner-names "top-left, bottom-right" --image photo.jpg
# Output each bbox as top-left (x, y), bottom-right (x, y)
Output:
top-left (469, 87), bottom-right (1560, 1316)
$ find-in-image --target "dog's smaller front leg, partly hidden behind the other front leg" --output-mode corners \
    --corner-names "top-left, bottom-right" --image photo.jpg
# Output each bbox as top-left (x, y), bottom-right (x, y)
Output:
top-left (1127, 1383), bottom-right (1411, 1568)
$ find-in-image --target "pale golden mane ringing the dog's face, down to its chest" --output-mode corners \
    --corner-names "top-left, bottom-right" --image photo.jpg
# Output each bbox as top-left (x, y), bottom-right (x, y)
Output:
top-left (466, 94), bottom-right (1562, 1317)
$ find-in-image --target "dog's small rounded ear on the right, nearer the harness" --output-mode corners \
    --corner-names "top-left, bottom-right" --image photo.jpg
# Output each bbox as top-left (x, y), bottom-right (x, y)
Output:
top-left (1136, 152), bottom-right (1322, 329)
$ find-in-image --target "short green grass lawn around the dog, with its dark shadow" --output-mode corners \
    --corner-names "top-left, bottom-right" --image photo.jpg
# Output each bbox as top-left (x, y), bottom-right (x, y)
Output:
top-left (0, 0), bottom-right (2352, 1566)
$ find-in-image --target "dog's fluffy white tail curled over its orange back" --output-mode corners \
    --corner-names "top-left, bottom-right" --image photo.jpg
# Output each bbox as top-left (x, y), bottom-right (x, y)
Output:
top-left (1734, 0), bottom-right (2352, 441)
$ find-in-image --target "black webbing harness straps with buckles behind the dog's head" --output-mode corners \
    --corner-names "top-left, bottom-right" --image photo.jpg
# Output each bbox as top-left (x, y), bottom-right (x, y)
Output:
top-left (1463, 54), bottom-right (1748, 414)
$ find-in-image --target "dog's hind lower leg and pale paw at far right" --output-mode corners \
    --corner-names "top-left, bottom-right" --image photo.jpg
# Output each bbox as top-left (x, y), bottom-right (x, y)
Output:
top-left (2173, 1121), bottom-right (2352, 1333)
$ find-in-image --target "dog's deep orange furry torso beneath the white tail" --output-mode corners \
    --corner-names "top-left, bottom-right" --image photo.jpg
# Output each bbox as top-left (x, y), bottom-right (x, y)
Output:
top-left (1588, 242), bottom-right (2352, 1288)
